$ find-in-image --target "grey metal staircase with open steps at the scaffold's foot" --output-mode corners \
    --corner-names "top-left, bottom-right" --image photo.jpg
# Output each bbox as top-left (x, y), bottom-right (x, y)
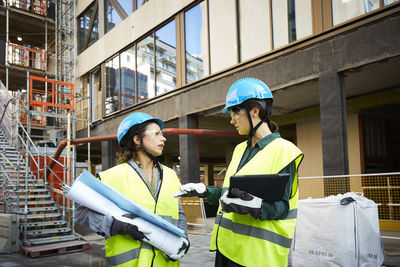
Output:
top-left (0, 129), bottom-right (78, 246)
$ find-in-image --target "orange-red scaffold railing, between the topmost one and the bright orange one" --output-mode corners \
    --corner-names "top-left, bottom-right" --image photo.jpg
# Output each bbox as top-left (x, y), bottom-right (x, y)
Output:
top-left (8, 42), bottom-right (47, 71)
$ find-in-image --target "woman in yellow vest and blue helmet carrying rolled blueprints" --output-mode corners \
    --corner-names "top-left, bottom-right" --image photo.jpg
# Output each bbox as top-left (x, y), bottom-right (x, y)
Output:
top-left (76, 112), bottom-right (189, 267)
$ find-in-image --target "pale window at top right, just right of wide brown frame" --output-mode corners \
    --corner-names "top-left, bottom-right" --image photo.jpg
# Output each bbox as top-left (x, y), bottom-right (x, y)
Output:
top-left (332, 0), bottom-right (379, 25)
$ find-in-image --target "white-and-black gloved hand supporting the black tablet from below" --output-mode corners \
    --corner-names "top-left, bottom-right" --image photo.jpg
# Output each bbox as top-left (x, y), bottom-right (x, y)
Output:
top-left (220, 188), bottom-right (262, 219)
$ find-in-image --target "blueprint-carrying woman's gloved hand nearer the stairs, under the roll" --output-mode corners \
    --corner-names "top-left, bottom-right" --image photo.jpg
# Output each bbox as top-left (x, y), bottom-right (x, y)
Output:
top-left (110, 213), bottom-right (151, 241)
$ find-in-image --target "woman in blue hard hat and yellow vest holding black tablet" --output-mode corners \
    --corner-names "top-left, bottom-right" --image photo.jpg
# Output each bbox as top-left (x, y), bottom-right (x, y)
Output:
top-left (177, 78), bottom-right (303, 267)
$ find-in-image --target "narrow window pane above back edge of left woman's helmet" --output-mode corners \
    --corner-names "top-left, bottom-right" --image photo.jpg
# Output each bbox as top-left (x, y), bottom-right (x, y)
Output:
top-left (120, 46), bottom-right (136, 109)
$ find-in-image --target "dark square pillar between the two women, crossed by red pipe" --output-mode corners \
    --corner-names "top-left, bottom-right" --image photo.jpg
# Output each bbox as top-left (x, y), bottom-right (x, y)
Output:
top-left (179, 114), bottom-right (200, 184)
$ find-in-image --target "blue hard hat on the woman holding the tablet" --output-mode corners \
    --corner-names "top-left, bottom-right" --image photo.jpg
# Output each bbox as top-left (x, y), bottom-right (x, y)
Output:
top-left (221, 78), bottom-right (274, 113)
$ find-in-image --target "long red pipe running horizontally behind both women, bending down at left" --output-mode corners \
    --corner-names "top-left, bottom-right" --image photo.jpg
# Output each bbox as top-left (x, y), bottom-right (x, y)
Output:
top-left (46, 128), bottom-right (241, 179)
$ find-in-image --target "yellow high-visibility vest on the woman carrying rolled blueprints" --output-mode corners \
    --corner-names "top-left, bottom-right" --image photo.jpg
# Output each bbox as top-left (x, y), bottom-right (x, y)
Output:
top-left (99, 163), bottom-right (181, 267)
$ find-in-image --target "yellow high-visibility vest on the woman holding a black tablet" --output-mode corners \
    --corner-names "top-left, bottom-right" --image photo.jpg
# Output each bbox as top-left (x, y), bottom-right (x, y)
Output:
top-left (210, 138), bottom-right (303, 267)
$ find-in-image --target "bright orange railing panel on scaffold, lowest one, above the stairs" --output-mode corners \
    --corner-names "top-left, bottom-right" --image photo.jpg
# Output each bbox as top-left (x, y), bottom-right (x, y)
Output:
top-left (29, 75), bottom-right (75, 110)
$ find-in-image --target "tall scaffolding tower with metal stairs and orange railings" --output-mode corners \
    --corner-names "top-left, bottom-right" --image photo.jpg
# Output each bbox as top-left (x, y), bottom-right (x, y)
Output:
top-left (0, 0), bottom-right (87, 251)
